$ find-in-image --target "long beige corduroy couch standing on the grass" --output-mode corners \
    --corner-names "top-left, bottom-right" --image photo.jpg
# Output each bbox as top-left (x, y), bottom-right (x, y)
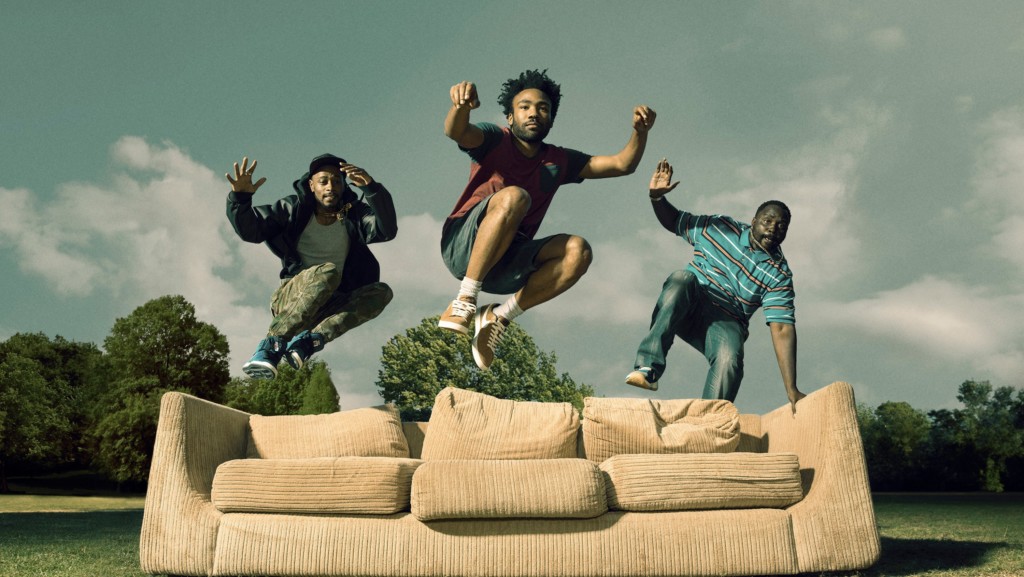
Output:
top-left (140, 382), bottom-right (880, 577)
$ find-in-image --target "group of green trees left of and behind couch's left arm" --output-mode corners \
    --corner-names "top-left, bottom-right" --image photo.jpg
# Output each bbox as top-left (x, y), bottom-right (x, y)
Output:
top-left (0, 295), bottom-right (338, 492)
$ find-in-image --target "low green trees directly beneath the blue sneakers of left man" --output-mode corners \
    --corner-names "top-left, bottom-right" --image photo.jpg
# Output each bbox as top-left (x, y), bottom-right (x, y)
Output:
top-left (224, 359), bottom-right (338, 415)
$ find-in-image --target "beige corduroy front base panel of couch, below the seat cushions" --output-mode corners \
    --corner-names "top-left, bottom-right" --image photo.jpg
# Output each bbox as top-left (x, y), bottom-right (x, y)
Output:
top-left (214, 509), bottom-right (797, 577)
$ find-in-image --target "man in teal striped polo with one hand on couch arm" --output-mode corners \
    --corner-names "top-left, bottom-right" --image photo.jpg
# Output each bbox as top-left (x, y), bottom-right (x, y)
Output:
top-left (626, 159), bottom-right (805, 410)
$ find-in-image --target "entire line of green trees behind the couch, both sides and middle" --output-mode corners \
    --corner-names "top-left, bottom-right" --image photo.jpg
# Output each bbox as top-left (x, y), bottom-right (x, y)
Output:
top-left (0, 295), bottom-right (1024, 492)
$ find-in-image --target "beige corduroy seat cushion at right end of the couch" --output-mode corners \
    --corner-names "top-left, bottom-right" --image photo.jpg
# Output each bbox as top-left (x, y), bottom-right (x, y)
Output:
top-left (601, 453), bottom-right (804, 511)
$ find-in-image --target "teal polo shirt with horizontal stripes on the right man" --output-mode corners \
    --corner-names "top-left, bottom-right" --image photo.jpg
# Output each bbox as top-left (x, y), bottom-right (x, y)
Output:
top-left (676, 210), bottom-right (796, 324)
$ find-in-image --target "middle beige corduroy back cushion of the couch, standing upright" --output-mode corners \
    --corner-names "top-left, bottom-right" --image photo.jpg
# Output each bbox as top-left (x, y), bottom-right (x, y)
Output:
top-left (422, 386), bottom-right (580, 460)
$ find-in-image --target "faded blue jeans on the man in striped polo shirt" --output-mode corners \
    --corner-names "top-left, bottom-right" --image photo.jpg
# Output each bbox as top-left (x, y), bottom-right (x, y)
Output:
top-left (635, 271), bottom-right (749, 401)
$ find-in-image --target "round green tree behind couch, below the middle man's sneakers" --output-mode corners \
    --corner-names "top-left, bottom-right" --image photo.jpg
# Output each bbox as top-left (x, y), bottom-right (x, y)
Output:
top-left (377, 317), bottom-right (594, 420)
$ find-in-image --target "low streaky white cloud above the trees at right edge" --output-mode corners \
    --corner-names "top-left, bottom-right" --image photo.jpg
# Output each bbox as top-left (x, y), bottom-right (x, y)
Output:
top-left (814, 276), bottom-right (1024, 381)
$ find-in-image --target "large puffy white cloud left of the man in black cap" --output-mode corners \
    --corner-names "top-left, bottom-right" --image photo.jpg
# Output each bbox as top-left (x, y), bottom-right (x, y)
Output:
top-left (0, 136), bottom-right (278, 360)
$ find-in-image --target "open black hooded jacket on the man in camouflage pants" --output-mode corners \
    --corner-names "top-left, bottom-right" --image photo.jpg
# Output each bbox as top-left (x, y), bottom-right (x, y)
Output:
top-left (227, 172), bottom-right (398, 292)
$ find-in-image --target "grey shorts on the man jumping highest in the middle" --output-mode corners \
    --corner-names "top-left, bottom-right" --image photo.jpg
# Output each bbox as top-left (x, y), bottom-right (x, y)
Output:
top-left (441, 197), bottom-right (554, 294)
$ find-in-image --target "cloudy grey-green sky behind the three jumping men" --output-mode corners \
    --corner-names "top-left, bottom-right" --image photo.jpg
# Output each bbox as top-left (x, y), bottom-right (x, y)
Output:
top-left (0, 0), bottom-right (1024, 412)
